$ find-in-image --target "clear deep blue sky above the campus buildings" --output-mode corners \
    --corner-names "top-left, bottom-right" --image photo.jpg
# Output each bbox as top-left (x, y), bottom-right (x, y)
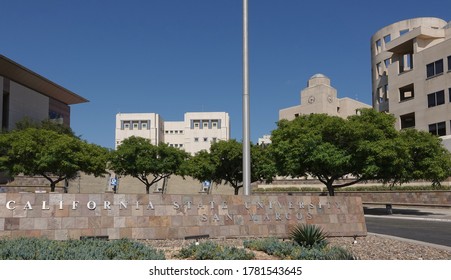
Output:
top-left (0, 0), bottom-right (451, 148)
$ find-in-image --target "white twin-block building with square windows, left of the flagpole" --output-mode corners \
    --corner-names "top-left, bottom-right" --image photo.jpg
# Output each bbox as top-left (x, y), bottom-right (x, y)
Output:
top-left (115, 112), bottom-right (230, 155)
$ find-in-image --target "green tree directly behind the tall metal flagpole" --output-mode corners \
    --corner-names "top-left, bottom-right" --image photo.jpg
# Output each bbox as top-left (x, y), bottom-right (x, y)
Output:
top-left (187, 139), bottom-right (275, 195)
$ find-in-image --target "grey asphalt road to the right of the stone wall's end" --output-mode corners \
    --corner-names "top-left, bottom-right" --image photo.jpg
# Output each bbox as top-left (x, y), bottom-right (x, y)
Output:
top-left (365, 216), bottom-right (451, 247)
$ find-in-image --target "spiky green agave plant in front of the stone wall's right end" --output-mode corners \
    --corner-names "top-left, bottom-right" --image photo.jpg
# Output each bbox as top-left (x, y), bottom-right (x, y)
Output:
top-left (290, 224), bottom-right (327, 248)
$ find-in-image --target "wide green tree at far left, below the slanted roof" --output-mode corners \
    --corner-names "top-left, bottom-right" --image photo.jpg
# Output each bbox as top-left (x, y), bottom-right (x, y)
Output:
top-left (0, 128), bottom-right (108, 192)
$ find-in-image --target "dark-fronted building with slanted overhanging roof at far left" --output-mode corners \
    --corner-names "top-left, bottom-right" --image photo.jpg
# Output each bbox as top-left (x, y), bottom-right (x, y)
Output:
top-left (0, 55), bottom-right (88, 130)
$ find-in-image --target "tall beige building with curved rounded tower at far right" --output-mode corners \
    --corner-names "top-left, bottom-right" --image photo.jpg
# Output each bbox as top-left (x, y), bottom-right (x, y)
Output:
top-left (371, 17), bottom-right (451, 149)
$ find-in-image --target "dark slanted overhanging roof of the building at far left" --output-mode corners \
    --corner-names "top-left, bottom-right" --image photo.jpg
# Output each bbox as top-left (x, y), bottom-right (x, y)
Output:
top-left (0, 54), bottom-right (89, 105)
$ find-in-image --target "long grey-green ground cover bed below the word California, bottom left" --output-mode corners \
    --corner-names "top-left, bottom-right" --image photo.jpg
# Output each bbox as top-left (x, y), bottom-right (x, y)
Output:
top-left (0, 237), bottom-right (165, 260)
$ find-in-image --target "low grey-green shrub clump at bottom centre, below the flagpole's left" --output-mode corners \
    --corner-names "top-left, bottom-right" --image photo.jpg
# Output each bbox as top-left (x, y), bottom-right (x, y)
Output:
top-left (177, 241), bottom-right (255, 260)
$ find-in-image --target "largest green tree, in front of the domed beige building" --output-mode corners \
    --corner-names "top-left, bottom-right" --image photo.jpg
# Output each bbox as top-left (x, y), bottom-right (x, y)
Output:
top-left (270, 109), bottom-right (407, 196)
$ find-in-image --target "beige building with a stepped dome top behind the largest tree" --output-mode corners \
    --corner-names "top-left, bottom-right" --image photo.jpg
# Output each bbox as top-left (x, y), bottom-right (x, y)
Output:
top-left (279, 74), bottom-right (371, 120)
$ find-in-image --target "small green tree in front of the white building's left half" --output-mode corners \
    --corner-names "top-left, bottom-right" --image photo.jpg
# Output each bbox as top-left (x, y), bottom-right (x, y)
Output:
top-left (110, 136), bottom-right (189, 194)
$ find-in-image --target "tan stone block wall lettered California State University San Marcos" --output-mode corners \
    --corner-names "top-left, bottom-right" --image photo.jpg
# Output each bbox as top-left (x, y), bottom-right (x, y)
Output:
top-left (0, 193), bottom-right (367, 240)
